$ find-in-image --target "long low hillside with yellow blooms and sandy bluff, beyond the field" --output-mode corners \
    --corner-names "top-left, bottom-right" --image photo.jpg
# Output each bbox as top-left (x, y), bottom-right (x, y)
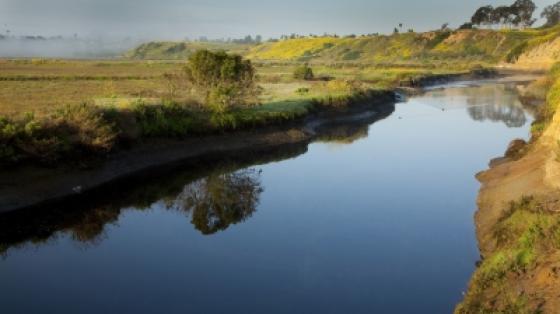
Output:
top-left (126, 27), bottom-right (560, 68)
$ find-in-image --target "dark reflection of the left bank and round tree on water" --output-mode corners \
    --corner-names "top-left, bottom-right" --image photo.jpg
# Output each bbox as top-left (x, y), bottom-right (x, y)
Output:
top-left (0, 105), bottom-right (394, 257)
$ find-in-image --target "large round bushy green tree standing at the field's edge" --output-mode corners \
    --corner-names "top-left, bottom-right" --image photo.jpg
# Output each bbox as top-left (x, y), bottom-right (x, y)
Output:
top-left (185, 50), bottom-right (257, 113)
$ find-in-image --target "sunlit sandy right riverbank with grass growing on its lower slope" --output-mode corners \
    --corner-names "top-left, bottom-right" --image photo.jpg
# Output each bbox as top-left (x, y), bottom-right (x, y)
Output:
top-left (456, 66), bottom-right (560, 313)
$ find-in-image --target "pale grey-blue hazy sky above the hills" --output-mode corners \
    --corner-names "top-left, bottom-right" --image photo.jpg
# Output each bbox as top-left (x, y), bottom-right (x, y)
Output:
top-left (0, 0), bottom-right (557, 39)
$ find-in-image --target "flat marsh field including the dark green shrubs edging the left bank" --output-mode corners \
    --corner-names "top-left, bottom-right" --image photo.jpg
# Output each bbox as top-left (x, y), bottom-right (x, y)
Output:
top-left (0, 54), bottom-right (457, 164)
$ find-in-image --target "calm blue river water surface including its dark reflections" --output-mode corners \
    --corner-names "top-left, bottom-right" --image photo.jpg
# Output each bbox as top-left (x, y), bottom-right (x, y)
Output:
top-left (0, 82), bottom-right (532, 313)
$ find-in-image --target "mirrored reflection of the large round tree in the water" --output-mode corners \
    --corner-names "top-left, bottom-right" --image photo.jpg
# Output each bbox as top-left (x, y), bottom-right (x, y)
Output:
top-left (170, 169), bottom-right (263, 235)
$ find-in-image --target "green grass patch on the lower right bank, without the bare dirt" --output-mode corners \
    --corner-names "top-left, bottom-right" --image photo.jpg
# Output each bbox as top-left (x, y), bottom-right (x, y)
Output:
top-left (456, 197), bottom-right (560, 313)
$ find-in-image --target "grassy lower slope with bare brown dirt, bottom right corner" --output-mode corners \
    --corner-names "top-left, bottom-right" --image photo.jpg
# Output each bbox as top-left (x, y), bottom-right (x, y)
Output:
top-left (456, 197), bottom-right (560, 314)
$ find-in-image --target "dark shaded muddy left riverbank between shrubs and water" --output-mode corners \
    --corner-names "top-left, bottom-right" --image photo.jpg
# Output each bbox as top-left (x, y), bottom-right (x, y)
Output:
top-left (0, 91), bottom-right (395, 213)
